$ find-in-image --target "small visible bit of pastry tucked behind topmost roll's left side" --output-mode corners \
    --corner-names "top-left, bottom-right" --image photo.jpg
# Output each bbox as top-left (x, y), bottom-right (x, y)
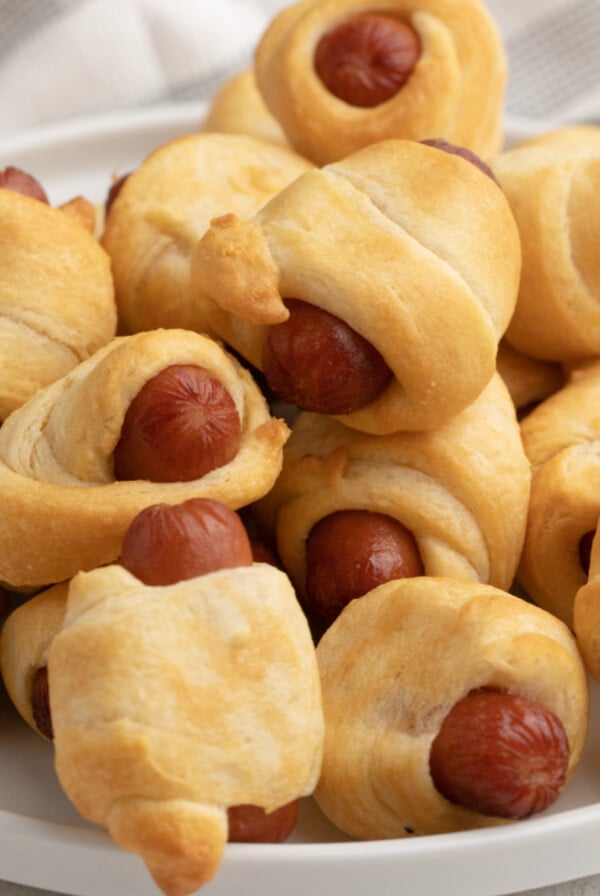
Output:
top-left (202, 68), bottom-right (290, 149)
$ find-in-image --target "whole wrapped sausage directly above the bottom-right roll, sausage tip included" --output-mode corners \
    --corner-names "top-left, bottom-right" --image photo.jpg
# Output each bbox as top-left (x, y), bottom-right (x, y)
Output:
top-left (254, 375), bottom-right (530, 622)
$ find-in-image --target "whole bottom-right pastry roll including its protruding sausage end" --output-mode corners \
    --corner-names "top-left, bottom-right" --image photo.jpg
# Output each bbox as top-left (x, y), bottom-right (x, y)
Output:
top-left (315, 577), bottom-right (589, 839)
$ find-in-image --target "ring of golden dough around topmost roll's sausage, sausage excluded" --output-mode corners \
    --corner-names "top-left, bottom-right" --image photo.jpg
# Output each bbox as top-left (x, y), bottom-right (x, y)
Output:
top-left (255, 0), bottom-right (507, 165)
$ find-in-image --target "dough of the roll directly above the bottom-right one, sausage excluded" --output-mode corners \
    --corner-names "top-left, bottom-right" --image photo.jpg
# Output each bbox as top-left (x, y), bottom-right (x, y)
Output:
top-left (254, 375), bottom-right (530, 596)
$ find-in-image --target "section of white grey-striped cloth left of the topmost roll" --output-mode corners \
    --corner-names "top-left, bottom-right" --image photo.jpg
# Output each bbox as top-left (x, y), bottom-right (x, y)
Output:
top-left (0, 0), bottom-right (283, 135)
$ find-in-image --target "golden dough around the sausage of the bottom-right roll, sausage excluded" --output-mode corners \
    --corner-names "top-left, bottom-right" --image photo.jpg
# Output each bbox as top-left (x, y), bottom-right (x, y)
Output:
top-left (315, 578), bottom-right (589, 839)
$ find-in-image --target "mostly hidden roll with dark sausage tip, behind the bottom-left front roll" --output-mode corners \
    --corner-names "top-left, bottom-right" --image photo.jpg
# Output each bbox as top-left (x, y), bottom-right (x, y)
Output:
top-left (0, 582), bottom-right (69, 740)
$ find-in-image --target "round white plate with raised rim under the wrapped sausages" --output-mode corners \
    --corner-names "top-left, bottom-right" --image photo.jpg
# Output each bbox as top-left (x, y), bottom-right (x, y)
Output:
top-left (0, 105), bottom-right (600, 896)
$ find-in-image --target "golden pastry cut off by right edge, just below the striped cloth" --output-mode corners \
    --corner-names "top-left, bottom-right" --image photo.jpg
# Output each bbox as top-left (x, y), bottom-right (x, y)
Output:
top-left (493, 127), bottom-right (600, 363)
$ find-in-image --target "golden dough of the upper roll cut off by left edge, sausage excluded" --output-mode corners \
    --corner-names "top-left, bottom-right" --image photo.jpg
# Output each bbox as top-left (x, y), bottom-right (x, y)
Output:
top-left (0, 189), bottom-right (117, 421)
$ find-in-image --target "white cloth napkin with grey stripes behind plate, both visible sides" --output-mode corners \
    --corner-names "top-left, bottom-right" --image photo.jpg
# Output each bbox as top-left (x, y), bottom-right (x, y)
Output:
top-left (0, 0), bottom-right (600, 134)
